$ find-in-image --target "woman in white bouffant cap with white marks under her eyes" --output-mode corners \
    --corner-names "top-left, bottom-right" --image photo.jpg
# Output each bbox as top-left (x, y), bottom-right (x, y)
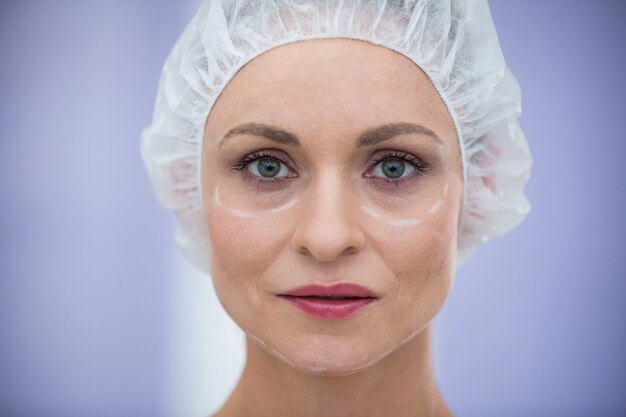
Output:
top-left (142, 0), bottom-right (531, 417)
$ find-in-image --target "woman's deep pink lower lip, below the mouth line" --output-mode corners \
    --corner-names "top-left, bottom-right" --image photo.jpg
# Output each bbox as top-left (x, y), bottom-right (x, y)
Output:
top-left (279, 295), bottom-right (376, 320)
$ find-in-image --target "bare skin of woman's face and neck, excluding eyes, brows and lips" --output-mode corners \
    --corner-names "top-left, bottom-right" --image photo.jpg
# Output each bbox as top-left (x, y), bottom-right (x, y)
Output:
top-left (201, 39), bottom-right (463, 417)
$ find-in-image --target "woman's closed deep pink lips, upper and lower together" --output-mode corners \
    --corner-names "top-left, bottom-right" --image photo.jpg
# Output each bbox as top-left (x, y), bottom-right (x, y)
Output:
top-left (278, 283), bottom-right (378, 319)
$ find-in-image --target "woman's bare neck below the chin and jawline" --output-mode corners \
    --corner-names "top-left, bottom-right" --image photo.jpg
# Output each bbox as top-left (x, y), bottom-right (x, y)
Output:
top-left (214, 324), bottom-right (452, 417)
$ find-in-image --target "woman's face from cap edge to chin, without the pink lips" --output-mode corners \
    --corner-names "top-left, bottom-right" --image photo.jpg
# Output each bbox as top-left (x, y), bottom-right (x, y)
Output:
top-left (202, 39), bottom-right (462, 375)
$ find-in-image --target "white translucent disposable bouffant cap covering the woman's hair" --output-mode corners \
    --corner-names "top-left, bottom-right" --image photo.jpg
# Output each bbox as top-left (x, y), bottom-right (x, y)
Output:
top-left (141, 0), bottom-right (532, 273)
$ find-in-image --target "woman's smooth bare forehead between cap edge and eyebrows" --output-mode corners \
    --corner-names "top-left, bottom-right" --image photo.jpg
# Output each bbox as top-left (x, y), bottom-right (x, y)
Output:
top-left (207, 39), bottom-right (455, 145)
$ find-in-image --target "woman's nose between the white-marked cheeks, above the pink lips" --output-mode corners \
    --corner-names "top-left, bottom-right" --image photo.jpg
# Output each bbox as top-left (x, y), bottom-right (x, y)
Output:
top-left (291, 171), bottom-right (365, 262)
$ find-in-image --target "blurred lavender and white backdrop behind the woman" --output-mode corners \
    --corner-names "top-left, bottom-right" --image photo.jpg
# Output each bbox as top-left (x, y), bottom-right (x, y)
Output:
top-left (0, 0), bottom-right (626, 417)
